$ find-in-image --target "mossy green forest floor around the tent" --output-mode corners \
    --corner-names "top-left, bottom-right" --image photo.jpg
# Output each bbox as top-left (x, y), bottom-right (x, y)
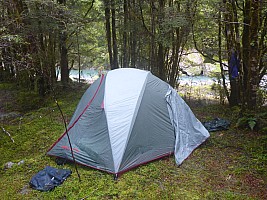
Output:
top-left (0, 84), bottom-right (267, 200)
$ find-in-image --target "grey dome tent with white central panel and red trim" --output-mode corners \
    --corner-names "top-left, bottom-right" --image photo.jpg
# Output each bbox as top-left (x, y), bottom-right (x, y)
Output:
top-left (47, 68), bottom-right (209, 176)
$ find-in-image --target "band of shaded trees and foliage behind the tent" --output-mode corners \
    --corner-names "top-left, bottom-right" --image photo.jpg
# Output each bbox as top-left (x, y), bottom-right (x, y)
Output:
top-left (0, 0), bottom-right (267, 109)
